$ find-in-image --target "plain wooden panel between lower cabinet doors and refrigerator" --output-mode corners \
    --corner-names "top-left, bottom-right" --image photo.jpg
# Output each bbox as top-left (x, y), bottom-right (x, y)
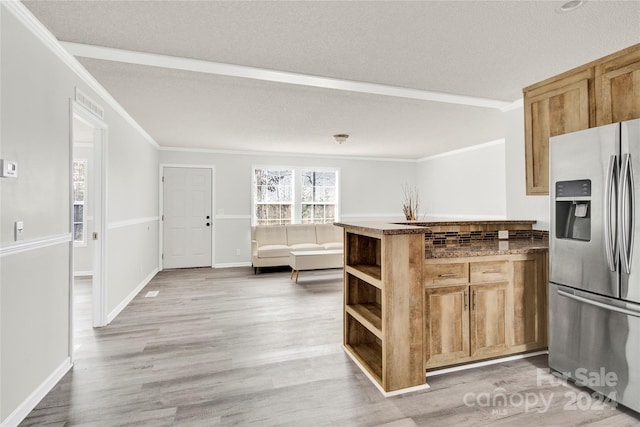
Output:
top-left (507, 256), bottom-right (547, 351)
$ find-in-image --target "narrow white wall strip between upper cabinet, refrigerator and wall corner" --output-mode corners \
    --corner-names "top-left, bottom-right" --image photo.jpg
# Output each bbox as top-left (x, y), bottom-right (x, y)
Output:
top-left (504, 107), bottom-right (549, 230)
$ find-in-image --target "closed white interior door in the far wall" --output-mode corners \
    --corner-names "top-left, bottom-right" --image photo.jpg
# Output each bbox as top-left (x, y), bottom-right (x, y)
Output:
top-left (163, 167), bottom-right (213, 268)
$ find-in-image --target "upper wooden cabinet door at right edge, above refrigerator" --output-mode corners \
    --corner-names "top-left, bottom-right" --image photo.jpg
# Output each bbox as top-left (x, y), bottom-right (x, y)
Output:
top-left (595, 44), bottom-right (640, 126)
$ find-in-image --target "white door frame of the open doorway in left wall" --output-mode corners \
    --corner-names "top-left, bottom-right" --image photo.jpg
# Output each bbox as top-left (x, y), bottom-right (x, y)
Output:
top-left (69, 99), bottom-right (109, 361)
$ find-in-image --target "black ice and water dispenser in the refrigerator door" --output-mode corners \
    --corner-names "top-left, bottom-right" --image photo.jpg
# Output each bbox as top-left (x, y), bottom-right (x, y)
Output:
top-left (555, 179), bottom-right (591, 241)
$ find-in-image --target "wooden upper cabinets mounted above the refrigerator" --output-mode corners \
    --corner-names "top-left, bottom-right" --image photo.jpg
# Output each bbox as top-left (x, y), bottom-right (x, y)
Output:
top-left (523, 44), bottom-right (640, 195)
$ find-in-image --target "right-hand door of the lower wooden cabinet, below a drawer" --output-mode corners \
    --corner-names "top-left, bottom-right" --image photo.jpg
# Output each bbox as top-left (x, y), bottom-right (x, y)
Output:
top-left (470, 282), bottom-right (509, 357)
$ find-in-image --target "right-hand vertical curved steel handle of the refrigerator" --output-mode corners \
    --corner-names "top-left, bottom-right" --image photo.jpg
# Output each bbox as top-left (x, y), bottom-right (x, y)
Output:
top-left (618, 153), bottom-right (635, 274)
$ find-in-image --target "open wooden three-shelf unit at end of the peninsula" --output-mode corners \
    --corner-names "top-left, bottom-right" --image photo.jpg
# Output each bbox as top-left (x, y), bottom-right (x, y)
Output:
top-left (343, 225), bottom-right (425, 392)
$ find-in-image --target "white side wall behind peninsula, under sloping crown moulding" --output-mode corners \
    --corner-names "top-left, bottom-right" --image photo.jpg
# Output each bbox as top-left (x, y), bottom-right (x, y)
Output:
top-left (417, 141), bottom-right (507, 219)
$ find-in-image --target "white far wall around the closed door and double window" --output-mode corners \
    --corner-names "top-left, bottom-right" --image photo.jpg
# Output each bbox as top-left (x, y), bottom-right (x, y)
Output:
top-left (160, 151), bottom-right (417, 267)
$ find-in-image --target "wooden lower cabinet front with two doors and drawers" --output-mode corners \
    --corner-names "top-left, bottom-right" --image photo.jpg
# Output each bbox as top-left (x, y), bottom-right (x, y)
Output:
top-left (423, 253), bottom-right (547, 369)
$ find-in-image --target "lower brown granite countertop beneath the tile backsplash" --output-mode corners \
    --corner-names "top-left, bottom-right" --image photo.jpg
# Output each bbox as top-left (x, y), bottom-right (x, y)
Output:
top-left (425, 239), bottom-right (549, 258)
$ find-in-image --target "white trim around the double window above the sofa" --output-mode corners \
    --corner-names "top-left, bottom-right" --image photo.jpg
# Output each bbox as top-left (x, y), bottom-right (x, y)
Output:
top-left (251, 165), bottom-right (342, 226)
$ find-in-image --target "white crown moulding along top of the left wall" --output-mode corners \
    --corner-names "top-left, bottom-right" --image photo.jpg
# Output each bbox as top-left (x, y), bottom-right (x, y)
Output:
top-left (0, 0), bottom-right (160, 150)
